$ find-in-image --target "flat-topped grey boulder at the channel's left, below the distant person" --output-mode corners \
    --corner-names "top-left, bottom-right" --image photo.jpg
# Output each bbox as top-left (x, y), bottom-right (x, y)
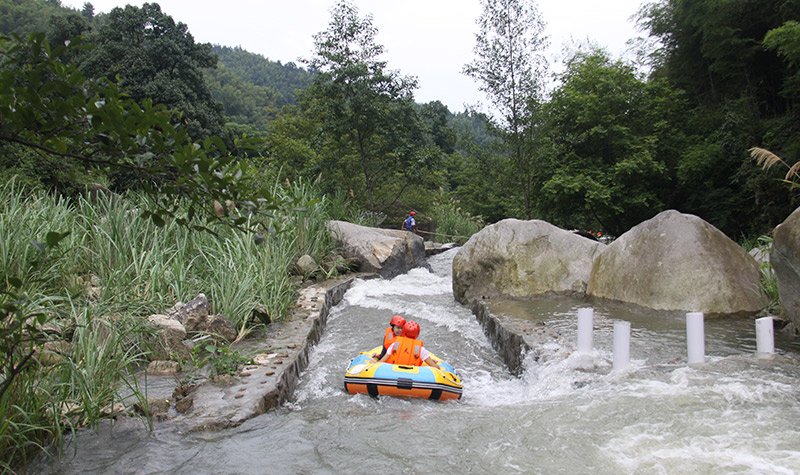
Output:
top-left (326, 221), bottom-right (428, 278)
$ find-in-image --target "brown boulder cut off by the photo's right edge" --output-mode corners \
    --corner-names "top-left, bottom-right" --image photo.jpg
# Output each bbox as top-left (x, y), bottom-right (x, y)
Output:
top-left (769, 208), bottom-right (800, 328)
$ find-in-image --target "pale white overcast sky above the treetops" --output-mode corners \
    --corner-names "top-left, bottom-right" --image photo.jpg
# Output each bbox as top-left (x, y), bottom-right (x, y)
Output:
top-left (62, 0), bottom-right (645, 112)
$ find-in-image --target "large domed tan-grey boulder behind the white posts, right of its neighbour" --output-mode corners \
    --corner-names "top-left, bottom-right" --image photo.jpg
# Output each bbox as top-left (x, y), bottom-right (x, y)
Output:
top-left (588, 210), bottom-right (766, 315)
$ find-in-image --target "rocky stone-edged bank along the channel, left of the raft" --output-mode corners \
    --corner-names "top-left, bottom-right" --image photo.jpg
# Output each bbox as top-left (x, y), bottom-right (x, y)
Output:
top-left (138, 274), bottom-right (378, 432)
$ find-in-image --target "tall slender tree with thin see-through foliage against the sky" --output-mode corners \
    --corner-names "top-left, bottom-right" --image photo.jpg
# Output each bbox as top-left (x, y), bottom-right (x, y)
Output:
top-left (464, 0), bottom-right (547, 219)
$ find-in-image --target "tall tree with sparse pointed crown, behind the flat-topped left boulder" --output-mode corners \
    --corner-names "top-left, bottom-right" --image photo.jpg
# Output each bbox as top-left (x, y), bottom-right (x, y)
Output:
top-left (300, 1), bottom-right (438, 218)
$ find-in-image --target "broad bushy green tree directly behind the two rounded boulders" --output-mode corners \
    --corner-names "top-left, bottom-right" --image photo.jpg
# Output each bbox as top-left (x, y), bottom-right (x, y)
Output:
top-left (540, 49), bottom-right (683, 236)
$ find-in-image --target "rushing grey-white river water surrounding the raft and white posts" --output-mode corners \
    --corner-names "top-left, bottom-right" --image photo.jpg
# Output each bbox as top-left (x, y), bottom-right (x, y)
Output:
top-left (28, 251), bottom-right (800, 474)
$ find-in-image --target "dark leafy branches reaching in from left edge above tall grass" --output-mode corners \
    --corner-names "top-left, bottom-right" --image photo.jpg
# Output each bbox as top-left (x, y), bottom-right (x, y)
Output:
top-left (0, 33), bottom-right (282, 229)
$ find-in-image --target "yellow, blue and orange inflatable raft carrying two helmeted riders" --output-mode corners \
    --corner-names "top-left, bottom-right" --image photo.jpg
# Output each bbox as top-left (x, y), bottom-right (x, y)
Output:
top-left (344, 346), bottom-right (461, 401)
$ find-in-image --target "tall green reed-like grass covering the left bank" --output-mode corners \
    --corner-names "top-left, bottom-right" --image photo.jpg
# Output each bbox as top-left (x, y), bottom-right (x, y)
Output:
top-left (0, 180), bottom-right (333, 472)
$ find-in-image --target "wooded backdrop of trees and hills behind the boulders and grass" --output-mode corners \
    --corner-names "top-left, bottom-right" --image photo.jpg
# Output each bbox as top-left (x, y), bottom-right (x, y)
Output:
top-left (0, 0), bottom-right (800, 237)
